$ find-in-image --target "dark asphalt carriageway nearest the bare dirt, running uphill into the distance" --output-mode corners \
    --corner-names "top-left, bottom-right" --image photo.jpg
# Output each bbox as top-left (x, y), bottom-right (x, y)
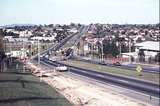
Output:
top-left (35, 24), bottom-right (160, 98)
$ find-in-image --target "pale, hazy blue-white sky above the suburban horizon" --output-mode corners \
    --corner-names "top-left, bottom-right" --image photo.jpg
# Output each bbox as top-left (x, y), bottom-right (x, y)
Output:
top-left (0, 0), bottom-right (159, 25)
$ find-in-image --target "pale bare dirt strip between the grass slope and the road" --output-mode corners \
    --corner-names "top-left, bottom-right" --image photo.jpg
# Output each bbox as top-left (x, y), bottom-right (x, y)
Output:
top-left (27, 62), bottom-right (150, 106)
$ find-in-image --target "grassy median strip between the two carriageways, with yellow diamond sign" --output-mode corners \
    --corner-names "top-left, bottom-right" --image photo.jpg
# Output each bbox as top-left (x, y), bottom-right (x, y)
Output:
top-left (64, 60), bottom-right (160, 84)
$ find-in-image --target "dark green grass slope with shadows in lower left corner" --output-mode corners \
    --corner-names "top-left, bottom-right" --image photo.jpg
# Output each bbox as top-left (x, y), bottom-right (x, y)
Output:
top-left (0, 61), bottom-right (72, 106)
